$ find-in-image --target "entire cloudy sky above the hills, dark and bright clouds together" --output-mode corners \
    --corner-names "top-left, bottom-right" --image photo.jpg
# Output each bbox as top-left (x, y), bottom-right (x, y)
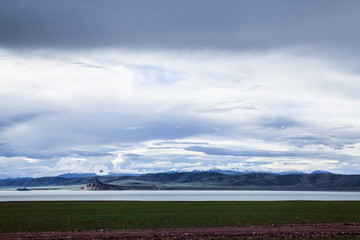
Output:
top-left (0, 0), bottom-right (360, 178)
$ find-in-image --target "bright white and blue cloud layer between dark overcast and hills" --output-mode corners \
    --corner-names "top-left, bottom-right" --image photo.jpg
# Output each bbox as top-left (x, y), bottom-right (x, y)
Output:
top-left (0, 49), bottom-right (360, 176)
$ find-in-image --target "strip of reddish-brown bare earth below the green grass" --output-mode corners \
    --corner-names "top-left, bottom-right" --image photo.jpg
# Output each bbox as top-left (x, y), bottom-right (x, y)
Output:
top-left (0, 223), bottom-right (360, 240)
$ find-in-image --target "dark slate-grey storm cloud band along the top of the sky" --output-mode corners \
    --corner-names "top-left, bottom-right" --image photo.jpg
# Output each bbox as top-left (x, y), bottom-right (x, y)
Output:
top-left (0, 0), bottom-right (360, 49)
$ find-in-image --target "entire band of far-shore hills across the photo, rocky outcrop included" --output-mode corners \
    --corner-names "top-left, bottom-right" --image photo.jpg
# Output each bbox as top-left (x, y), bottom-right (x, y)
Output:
top-left (0, 171), bottom-right (360, 191)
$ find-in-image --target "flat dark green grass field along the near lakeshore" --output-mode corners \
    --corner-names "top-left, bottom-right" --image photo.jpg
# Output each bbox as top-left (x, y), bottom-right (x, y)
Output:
top-left (0, 201), bottom-right (360, 233)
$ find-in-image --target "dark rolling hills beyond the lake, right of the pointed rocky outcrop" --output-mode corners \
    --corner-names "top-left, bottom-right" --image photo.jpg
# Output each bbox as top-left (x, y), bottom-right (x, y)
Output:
top-left (83, 171), bottom-right (360, 191)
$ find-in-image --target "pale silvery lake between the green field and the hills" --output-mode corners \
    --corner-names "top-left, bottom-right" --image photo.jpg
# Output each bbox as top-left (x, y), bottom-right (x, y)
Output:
top-left (0, 190), bottom-right (360, 202)
